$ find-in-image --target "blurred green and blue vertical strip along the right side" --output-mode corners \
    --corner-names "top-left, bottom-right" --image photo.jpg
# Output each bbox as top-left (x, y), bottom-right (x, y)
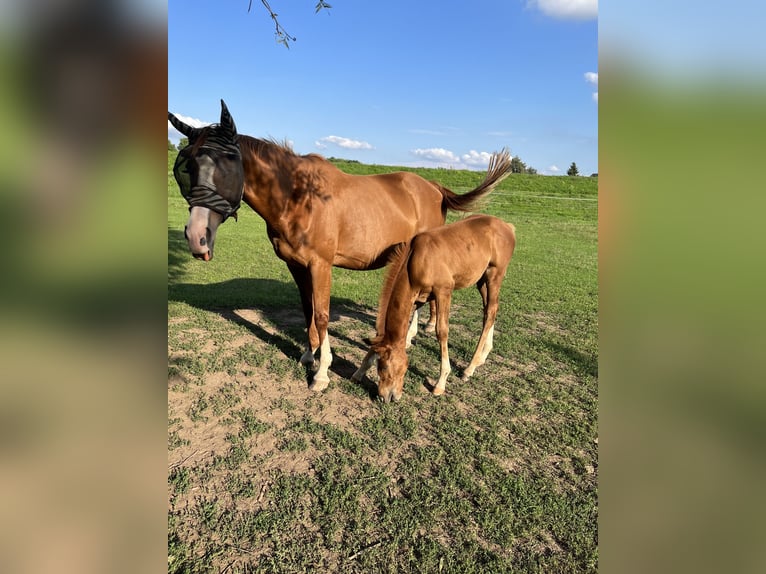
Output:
top-left (599, 1), bottom-right (766, 573)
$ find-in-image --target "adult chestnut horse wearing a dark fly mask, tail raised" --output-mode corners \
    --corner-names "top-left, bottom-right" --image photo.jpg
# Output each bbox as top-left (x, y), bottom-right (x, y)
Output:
top-left (168, 100), bottom-right (511, 390)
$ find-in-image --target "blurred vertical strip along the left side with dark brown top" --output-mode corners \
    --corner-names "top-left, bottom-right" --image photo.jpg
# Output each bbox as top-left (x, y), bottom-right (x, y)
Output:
top-left (0, 0), bottom-right (167, 573)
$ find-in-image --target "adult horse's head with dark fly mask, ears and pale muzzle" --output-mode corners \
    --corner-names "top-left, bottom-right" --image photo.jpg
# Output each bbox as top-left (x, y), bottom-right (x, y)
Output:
top-left (168, 100), bottom-right (245, 261)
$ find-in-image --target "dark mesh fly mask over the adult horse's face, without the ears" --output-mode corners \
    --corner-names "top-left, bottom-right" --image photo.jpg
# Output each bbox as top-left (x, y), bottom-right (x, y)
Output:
top-left (173, 137), bottom-right (245, 221)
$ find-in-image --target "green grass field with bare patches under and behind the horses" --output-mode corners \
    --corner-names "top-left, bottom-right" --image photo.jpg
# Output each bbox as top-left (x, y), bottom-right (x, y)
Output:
top-left (168, 152), bottom-right (598, 573)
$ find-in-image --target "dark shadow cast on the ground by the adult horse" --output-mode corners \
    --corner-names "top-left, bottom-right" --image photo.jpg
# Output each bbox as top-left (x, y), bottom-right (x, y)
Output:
top-left (168, 229), bottom-right (377, 399)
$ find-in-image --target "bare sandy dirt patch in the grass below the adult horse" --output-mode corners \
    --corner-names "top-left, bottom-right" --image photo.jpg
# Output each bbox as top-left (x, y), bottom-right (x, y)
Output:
top-left (168, 309), bottom-right (384, 480)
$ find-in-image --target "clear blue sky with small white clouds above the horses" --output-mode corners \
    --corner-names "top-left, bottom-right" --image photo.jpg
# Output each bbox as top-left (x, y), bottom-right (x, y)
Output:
top-left (168, 0), bottom-right (598, 175)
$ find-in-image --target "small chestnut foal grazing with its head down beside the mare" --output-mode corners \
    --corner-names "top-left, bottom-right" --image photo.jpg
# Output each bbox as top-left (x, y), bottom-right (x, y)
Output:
top-left (351, 215), bottom-right (516, 402)
